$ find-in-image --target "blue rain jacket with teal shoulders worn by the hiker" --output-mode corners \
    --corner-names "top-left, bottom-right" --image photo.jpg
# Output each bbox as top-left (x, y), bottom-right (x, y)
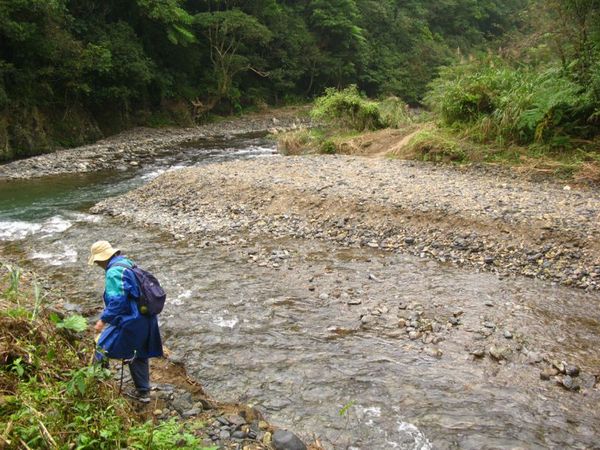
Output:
top-left (98, 256), bottom-right (163, 359)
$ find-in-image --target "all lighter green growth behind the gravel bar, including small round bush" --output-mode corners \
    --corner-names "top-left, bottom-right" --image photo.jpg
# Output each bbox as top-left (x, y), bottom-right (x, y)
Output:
top-left (281, 0), bottom-right (600, 181)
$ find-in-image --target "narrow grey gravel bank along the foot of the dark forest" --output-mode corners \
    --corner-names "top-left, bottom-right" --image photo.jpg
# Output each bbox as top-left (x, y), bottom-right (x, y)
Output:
top-left (0, 108), bottom-right (308, 181)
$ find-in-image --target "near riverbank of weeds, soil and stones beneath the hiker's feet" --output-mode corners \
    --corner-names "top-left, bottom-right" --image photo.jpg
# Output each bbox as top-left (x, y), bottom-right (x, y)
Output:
top-left (0, 261), bottom-right (320, 450)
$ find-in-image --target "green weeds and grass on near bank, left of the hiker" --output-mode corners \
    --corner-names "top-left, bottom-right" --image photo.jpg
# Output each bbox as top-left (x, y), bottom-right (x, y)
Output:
top-left (0, 266), bottom-right (213, 450)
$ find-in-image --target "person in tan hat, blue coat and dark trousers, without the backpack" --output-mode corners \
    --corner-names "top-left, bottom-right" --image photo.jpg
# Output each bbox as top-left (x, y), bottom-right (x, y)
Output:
top-left (88, 241), bottom-right (163, 403)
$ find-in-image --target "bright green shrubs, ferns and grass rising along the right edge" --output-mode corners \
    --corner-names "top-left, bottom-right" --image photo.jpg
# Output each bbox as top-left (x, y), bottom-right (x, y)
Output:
top-left (414, 0), bottom-right (600, 181)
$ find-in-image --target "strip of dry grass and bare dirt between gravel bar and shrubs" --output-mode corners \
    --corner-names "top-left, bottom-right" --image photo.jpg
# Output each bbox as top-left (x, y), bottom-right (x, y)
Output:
top-left (278, 125), bottom-right (600, 188)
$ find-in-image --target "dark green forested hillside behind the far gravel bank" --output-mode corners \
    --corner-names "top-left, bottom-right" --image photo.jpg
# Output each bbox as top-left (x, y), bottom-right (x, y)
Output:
top-left (0, 0), bottom-right (527, 160)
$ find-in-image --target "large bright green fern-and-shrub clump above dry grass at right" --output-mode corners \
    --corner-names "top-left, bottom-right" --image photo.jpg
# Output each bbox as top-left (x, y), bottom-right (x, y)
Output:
top-left (426, 60), bottom-right (598, 147)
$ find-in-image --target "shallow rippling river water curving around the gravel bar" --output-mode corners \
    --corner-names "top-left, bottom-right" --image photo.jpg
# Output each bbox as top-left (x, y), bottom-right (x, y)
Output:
top-left (0, 136), bottom-right (600, 449)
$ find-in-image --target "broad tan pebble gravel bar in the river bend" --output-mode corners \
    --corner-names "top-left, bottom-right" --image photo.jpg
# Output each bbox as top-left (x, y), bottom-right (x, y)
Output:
top-left (95, 156), bottom-right (600, 289)
